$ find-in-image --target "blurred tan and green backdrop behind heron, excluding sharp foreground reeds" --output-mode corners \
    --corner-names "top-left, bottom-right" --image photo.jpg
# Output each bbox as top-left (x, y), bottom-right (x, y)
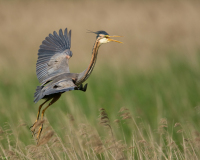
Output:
top-left (0, 0), bottom-right (200, 156)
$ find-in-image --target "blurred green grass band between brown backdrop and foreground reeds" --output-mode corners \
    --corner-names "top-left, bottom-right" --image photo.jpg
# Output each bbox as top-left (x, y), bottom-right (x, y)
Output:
top-left (0, 52), bottom-right (200, 148)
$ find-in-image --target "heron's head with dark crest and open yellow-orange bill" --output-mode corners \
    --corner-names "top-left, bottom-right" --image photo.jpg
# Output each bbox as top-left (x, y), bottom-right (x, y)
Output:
top-left (90, 31), bottom-right (122, 44)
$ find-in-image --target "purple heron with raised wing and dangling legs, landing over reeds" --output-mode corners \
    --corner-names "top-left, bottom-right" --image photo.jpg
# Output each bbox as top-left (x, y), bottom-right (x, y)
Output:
top-left (31, 28), bottom-right (122, 141)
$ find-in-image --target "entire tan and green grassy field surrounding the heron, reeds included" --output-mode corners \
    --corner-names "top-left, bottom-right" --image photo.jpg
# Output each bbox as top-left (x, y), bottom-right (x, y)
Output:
top-left (0, 1), bottom-right (200, 160)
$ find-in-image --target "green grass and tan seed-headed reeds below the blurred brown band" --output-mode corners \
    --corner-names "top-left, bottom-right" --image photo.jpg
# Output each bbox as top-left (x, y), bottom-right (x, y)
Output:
top-left (0, 55), bottom-right (200, 159)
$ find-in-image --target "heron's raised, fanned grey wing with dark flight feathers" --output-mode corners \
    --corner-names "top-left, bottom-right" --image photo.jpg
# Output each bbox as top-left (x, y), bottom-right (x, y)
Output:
top-left (36, 28), bottom-right (72, 83)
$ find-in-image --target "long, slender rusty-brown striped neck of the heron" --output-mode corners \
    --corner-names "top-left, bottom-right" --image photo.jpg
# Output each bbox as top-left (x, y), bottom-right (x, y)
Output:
top-left (76, 38), bottom-right (100, 85)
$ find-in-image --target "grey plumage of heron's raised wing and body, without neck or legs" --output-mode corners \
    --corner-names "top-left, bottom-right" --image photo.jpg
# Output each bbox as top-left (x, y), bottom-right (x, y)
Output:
top-left (34, 28), bottom-right (78, 103)
